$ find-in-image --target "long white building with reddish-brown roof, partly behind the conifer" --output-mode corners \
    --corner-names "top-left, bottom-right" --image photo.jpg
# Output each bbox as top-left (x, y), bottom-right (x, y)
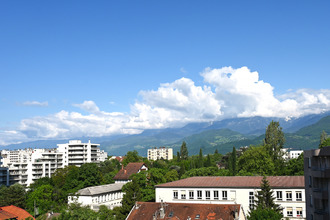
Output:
top-left (155, 176), bottom-right (306, 219)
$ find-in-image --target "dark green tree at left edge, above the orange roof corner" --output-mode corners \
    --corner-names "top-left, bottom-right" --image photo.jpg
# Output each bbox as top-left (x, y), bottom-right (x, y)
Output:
top-left (0, 184), bottom-right (26, 209)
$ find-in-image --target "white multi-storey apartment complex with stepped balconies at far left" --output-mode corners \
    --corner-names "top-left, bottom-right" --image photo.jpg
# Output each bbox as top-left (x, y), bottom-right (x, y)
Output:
top-left (0, 140), bottom-right (107, 186)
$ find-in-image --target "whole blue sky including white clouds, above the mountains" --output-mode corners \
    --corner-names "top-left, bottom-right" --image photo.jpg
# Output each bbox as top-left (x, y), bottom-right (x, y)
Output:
top-left (0, 0), bottom-right (330, 146)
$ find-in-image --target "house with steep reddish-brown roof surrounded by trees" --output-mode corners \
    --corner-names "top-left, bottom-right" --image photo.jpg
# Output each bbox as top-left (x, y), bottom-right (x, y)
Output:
top-left (113, 163), bottom-right (148, 183)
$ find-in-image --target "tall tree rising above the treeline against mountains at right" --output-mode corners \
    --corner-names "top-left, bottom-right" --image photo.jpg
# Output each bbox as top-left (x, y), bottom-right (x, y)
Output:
top-left (264, 121), bottom-right (285, 161)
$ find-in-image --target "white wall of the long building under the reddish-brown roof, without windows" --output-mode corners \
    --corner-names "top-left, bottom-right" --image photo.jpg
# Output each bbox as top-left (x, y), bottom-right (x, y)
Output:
top-left (156, 188), bottom-right (306, 219)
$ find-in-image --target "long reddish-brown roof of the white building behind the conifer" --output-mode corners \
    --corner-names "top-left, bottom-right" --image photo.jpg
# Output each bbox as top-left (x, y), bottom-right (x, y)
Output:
top-left (155, 176), bottom-right (305, 188)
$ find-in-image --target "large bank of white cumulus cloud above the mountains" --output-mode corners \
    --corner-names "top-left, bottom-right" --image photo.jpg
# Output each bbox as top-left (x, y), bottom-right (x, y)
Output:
top-left (0, 67), bottom-right (330, 144)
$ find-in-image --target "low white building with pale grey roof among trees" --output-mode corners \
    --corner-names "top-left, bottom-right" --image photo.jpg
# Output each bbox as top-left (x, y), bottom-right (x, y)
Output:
top-left (68, 183), bottom-right (124, 211)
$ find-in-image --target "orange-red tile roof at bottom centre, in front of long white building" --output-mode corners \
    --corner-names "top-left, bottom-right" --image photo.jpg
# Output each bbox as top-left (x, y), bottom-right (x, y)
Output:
top-left (127, 202), bottom-right (240, 220)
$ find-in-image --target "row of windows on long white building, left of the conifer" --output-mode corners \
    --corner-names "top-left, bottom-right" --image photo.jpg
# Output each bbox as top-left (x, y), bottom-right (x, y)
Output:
top-left (173, 190), bottom-right (228, 200)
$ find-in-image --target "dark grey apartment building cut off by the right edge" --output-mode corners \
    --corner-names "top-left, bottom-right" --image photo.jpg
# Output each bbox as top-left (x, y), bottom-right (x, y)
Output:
top-left (304, 146), bottom-right (330, 220)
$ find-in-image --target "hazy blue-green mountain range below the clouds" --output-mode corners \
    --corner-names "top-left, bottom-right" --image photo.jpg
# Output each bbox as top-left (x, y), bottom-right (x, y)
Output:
top-left (1, 112), bottom-right (330, 156)
